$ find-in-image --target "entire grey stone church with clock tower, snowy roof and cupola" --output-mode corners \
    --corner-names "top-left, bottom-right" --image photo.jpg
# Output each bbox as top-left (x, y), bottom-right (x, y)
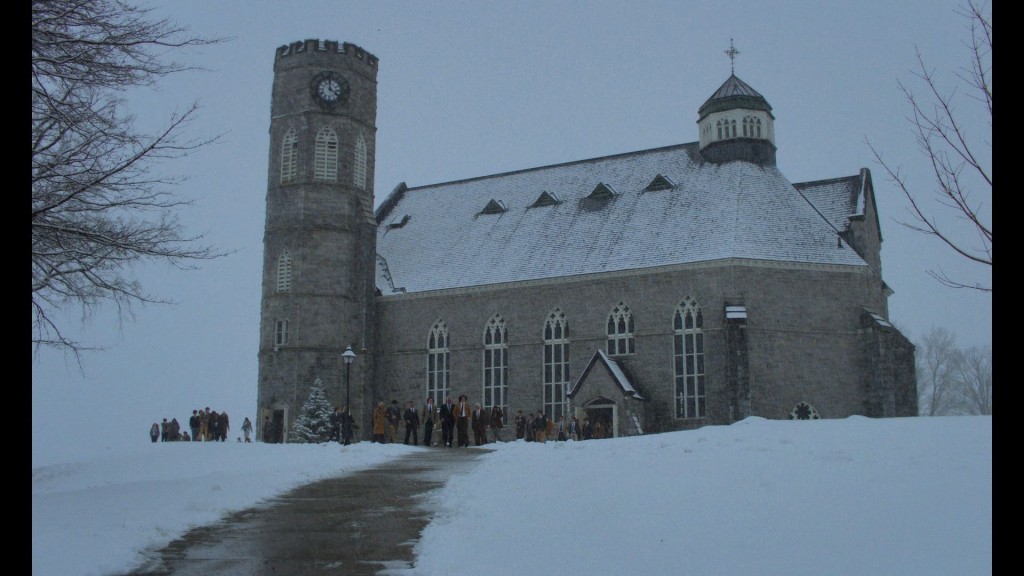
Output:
top-left (257, 39), bottom-right (918, 442)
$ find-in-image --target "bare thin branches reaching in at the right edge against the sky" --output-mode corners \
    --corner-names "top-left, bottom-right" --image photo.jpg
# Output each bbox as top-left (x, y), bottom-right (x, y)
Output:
top-left (868, 0), bottom-right (992, 291)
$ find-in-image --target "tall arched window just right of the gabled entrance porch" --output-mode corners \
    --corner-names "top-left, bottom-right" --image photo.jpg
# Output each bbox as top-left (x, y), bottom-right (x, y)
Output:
top-left (672, 296), bottom-right (707, 418)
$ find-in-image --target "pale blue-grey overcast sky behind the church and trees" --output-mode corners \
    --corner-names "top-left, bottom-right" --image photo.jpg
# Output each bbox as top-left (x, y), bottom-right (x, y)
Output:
top-left (33, 0), bottom-right (992, 461)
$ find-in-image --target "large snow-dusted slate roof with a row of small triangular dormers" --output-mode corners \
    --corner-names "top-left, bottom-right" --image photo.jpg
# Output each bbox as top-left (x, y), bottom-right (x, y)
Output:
top-left (376, 142), bottom-right (867, 295)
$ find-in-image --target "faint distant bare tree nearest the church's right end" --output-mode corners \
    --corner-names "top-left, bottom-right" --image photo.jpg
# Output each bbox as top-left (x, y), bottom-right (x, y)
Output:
top-left (916, 328), bottom-right (963, 416)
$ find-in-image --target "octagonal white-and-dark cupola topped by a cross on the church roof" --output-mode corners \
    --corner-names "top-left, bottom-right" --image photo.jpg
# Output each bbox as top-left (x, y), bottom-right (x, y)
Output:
top-left (697, 40), bottom-right (775, 165)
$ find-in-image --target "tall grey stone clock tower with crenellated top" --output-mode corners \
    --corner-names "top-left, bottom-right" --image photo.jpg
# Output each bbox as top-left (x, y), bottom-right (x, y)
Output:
top-left (257, 40), bottom-right (378, 442)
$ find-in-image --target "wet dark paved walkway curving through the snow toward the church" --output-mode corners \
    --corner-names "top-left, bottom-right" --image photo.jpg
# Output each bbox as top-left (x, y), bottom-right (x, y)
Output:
top-left (118, 448), bottom-right (485, 576)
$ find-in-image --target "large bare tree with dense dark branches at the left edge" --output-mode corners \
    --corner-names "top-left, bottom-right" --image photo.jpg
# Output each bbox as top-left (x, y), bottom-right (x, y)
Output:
top-left (32, 0), bottom-right (225, 357)
